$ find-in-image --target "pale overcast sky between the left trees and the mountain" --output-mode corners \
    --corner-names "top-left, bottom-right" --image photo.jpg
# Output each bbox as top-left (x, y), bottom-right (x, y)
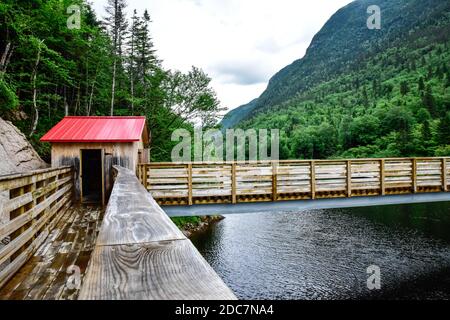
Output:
top-left (92, 0), bottom-right (352, 109)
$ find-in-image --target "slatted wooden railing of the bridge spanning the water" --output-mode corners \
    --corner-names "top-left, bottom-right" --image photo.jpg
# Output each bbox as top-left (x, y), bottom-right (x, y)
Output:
top-left (137, 158), bottom-right (450, 205)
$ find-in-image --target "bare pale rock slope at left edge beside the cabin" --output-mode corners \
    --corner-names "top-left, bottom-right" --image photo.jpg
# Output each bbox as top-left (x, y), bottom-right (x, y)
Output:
top-left (0, 118), bottom-right (48, 176)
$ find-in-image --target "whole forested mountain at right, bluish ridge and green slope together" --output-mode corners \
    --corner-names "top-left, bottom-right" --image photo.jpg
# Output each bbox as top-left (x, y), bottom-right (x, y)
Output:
top-left (222, 0), bottom-right (450, 159)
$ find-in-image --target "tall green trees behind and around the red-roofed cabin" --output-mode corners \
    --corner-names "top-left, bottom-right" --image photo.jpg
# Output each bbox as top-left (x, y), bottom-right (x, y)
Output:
top-left (0, 0), bottom-right (221, 161)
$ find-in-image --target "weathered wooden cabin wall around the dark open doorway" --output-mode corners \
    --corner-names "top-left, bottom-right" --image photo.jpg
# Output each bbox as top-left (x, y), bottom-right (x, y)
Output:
top-left (52, 142), bottom-right (142, 200)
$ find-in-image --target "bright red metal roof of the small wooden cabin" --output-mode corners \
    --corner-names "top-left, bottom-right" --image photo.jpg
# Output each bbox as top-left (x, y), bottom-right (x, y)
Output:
top-left (41, 117), bottom-right (148, 142)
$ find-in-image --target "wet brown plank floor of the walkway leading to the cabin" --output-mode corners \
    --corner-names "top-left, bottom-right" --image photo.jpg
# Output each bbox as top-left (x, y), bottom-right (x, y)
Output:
top-left (0, 206), bottom-right (103, 300)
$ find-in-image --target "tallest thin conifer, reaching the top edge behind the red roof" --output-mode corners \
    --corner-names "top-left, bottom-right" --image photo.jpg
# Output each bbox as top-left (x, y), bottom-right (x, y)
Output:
top-left (105, 0), bottom-right (128, 116)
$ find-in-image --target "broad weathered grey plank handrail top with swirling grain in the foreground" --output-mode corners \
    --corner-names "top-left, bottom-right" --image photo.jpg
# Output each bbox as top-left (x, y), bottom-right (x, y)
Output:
top-left (79, 167), bottom-right (236, 300)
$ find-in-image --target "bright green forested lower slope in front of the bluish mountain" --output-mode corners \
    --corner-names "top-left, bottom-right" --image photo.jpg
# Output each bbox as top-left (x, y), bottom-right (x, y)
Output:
top-left (241, 39), bottom-right (450, 159)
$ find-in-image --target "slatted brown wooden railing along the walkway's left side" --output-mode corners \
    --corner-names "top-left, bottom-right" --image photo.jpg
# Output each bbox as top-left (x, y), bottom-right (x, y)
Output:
top-left (0, 167), bottom-right (73, 287)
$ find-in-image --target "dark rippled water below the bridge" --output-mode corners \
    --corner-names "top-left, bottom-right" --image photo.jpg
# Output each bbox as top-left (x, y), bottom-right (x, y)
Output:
top-left (193, 203), bottom-right (450, 299)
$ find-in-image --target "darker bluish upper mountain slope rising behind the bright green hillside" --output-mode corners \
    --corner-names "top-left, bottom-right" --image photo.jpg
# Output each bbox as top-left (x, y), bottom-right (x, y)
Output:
top-left (222, 0), bottom-right (450, 128)
